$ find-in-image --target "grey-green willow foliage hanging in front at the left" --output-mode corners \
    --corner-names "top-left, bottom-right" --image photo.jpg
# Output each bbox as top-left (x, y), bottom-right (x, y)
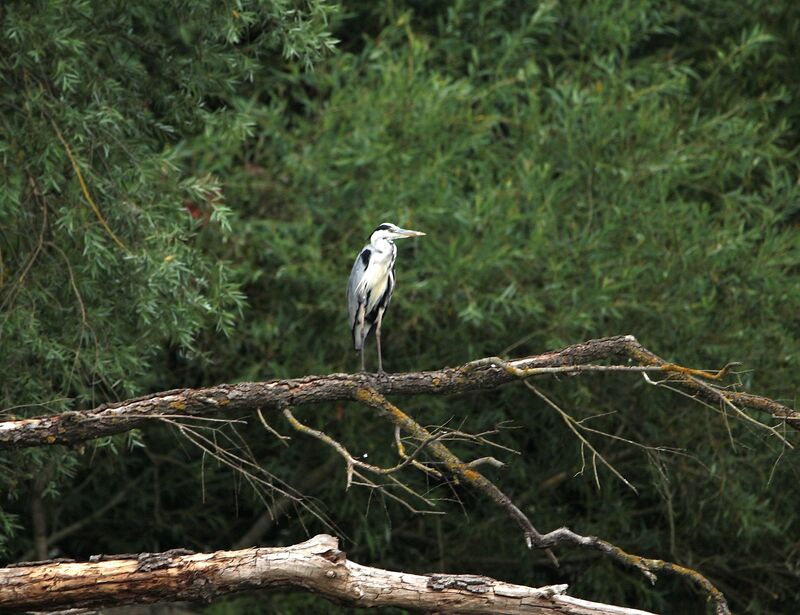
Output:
top-left (0, 0), bottom-right (334, 572)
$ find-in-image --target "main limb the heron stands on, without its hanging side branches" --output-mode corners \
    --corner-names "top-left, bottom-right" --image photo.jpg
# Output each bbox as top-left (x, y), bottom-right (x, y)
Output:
top-left (0, 335), bottom-right (800, 448)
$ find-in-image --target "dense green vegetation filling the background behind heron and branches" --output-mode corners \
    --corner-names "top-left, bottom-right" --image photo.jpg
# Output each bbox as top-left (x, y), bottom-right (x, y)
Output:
top-left (0, 0), bottom-right (800, 613)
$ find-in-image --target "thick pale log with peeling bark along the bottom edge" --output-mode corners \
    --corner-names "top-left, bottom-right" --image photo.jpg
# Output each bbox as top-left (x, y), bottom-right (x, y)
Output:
top-left (0, 534), bottom-right (652, 615)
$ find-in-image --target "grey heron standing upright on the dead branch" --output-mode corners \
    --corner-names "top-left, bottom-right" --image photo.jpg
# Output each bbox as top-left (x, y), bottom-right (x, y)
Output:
top-left (347, 222), bottom-right (425, 373)
